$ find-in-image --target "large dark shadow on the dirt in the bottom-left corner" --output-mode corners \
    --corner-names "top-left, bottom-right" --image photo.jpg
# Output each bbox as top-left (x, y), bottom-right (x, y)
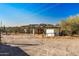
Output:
top-left (0, 44), bottom-right (30, 56)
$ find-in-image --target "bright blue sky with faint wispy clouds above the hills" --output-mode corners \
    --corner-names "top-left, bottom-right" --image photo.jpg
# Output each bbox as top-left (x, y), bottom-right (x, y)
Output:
top-left (0, 3), bottom-right (79, 26)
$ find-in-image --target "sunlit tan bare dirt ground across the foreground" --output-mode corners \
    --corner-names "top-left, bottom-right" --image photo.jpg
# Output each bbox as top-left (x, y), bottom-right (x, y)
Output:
top-left (1, 34), bottom-right (79, 56)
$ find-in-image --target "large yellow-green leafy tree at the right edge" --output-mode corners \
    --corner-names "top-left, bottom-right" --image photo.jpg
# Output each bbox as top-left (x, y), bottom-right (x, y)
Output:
top-left (59, 16), bottom-right (79, 35)
